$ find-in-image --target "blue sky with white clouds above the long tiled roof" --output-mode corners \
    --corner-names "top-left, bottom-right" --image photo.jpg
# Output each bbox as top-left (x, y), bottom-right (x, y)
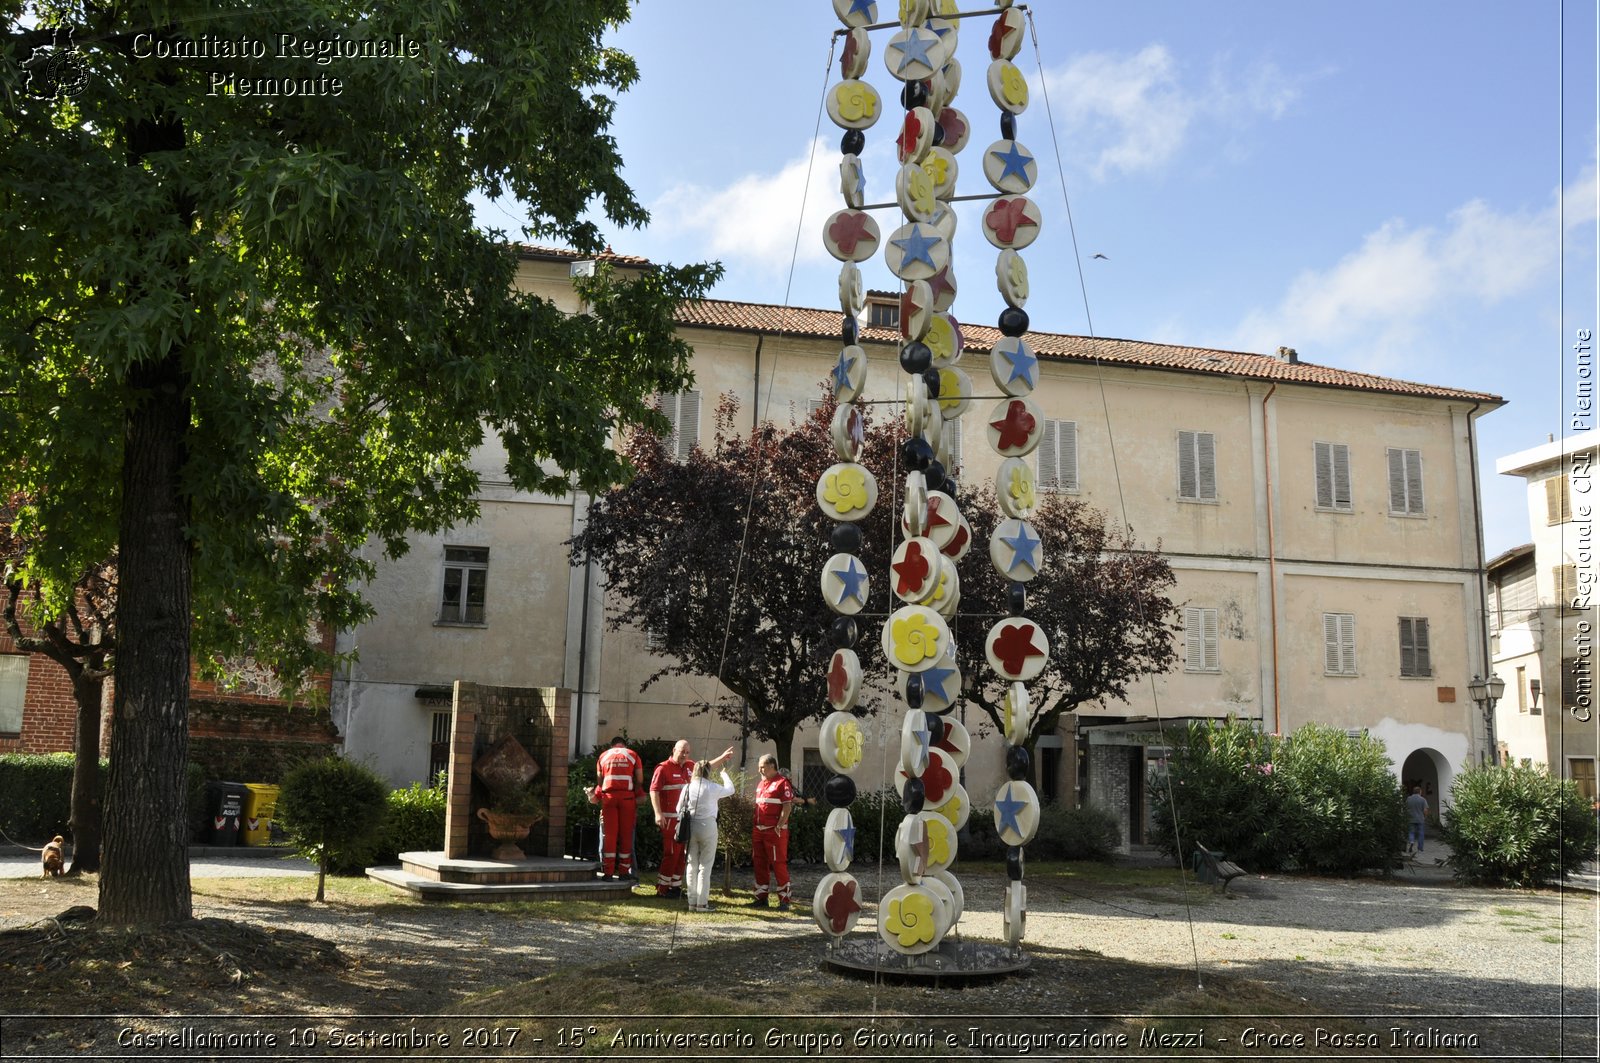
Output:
top-left (482, 0), bottom-right (1597, 557)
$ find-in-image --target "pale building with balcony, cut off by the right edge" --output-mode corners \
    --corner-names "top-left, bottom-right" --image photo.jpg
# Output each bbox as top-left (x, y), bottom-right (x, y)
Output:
top-left (1488, 434), bottom-right (1600, 799)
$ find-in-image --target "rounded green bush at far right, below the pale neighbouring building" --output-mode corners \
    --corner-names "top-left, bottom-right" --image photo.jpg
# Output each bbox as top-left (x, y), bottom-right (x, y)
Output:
top-left (1443, 764), bottom-right (1595, 887)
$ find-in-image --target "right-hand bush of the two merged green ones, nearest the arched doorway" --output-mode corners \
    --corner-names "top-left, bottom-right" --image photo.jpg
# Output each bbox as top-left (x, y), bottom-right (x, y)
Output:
top-left (1275, 724), bottom-right (1406, 874)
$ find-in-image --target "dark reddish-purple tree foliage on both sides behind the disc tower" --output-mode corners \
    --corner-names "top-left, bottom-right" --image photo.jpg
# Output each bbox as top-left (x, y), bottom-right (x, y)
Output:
top-left (573, 399), bottom-right (1176, 764)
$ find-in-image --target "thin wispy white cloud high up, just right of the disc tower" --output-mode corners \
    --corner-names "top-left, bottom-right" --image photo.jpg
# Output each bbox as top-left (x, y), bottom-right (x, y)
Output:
top-left (1045, 45), bottom-right (1299, 179)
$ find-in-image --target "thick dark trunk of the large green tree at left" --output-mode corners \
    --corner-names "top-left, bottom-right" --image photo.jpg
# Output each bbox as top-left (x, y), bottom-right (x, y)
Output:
top-left (99, 352), bottom-right (194, 925)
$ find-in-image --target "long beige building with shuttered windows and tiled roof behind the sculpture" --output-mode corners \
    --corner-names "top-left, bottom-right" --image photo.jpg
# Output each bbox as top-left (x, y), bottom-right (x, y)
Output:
top-left (334, 250), bottom-right (1502, 842)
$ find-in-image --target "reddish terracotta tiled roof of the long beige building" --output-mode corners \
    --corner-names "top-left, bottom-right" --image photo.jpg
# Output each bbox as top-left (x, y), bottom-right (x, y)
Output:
top-left (678, 299), bottom-right (1506, 405)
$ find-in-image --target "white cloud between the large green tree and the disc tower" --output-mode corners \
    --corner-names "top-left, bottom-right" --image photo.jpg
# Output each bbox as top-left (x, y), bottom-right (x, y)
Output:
top-left (650, 139), bottom-right (842, 272)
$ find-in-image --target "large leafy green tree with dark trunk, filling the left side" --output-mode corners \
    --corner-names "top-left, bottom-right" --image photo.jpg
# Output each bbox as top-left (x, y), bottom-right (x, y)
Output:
top-left (0, 0), bottom-right (714, 924)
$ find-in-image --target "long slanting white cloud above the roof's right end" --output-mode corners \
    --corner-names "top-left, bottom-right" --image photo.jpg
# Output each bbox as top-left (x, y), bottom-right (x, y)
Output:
top-left (1229, 166), bottom-right (1595, 365)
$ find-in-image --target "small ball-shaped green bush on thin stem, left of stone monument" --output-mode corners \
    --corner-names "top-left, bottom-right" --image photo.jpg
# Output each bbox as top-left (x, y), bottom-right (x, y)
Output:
top-left (277, 757), bottom-right (389, 901)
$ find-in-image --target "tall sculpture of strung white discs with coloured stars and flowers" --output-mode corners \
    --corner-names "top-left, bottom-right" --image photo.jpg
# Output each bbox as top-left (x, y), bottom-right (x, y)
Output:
top-left (813, 0), bottom-right (1050, 957)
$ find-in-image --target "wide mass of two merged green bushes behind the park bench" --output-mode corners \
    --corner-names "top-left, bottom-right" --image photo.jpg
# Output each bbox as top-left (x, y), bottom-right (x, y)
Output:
top-left (1150, 719), bottom-right (1405, 874)
